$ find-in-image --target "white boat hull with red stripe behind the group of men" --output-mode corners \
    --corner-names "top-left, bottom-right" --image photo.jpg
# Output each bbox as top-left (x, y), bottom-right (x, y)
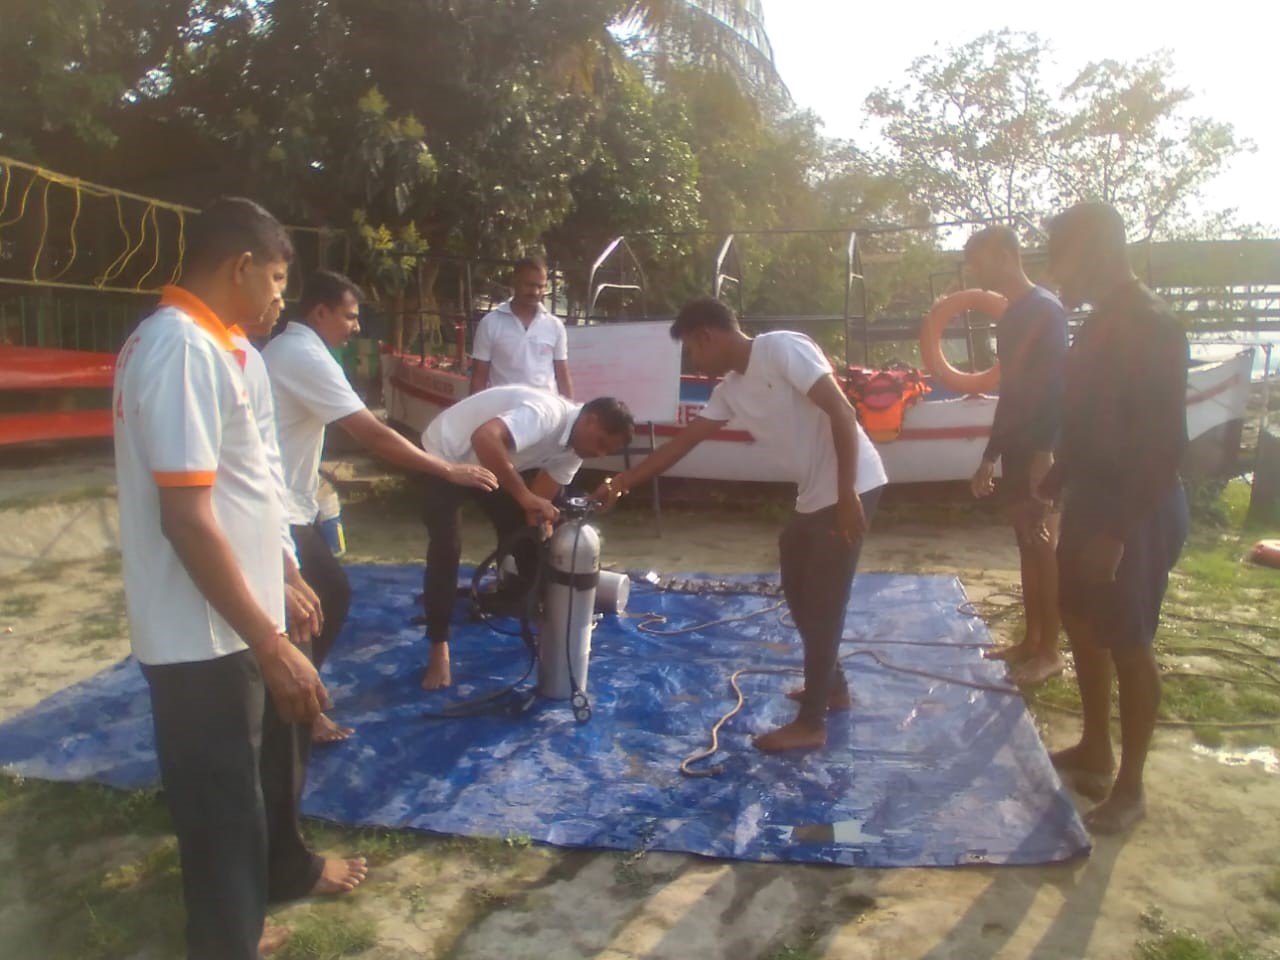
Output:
top-left (383, 351), bottom-right (1253, 484)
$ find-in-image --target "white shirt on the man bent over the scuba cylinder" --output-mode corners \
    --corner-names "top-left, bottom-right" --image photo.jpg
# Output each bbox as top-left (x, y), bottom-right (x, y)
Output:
top-left (422, 385), bottom-right (582, 486)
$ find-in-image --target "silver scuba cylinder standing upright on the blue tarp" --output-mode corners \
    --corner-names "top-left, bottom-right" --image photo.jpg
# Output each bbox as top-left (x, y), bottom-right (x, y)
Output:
top-left (538, 517), bottom-right (600, 700)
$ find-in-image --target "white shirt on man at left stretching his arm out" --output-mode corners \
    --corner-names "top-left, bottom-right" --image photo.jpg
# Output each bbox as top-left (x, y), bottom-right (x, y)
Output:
top-left (262, 321), bottom-right (365, 526)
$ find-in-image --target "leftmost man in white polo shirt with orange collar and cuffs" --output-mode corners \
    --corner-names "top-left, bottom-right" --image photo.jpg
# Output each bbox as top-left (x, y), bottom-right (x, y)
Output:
top-left (113, 198), bottom-right (365, 960)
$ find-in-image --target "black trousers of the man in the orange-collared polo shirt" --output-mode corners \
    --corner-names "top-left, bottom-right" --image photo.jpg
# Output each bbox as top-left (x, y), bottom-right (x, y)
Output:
top-left (142, 650), bottom-right (324, 960)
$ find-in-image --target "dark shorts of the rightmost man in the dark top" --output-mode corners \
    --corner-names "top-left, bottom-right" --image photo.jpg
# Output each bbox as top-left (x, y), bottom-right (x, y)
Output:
top-left (1057, 484), bottom-right (1190, 649)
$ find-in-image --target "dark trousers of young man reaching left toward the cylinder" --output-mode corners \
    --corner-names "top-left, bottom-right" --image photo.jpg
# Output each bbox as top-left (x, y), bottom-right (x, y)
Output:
top-left (778, 488), bottom-right (883, 727)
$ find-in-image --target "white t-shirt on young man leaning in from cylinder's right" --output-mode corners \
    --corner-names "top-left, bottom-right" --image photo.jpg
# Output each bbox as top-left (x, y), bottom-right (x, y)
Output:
top-left (699, 330), bottom-right (887, 513)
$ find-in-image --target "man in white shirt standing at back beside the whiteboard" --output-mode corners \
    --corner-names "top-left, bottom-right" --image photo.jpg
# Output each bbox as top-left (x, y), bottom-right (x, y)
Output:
top-left (471, 257), bottom-right (573, 399)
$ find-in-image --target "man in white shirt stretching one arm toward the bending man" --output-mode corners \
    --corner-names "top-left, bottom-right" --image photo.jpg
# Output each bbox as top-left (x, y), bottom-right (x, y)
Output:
top-left (262, 270), bottom-right (497, 742)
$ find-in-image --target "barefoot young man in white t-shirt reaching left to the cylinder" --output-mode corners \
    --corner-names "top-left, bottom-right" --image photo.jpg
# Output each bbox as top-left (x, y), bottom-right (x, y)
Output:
top-left (594, 297), bottom-right (887, 751)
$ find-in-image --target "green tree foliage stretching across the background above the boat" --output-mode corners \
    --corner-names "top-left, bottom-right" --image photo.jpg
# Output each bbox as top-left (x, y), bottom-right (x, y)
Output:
top-left (0, 0), bottom-right (1259, 332)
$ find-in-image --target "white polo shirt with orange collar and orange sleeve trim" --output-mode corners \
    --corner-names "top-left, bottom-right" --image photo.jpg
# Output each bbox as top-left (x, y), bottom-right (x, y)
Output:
top-left (113, 287), bottom-right (284, 664)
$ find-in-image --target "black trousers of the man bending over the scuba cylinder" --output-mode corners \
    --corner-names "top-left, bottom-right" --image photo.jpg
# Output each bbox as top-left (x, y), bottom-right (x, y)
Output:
top-left (422, 476), bottom-right (538, 644)
